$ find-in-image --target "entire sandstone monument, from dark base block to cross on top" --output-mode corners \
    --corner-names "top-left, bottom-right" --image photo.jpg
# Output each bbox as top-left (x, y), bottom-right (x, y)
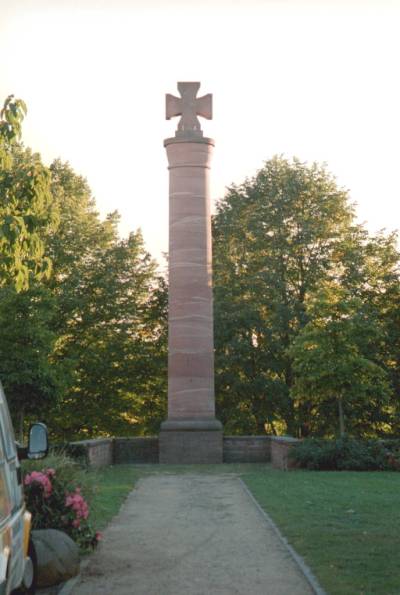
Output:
top-left (160, 83), bottom-right (222, 463)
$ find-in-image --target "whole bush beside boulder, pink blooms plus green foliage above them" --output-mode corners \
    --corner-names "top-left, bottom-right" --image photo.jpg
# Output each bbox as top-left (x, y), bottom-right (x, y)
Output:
top-left (23, 454), bottom-right (101, 550)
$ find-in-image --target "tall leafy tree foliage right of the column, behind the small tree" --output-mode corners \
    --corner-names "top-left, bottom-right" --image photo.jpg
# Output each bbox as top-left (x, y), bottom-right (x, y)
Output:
top-left (213, 157), bottom-right (399, 436)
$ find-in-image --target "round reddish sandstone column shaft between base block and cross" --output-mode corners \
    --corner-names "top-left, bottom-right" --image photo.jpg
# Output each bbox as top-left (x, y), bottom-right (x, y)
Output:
top-left (164, 138), bottom-right (215, 421)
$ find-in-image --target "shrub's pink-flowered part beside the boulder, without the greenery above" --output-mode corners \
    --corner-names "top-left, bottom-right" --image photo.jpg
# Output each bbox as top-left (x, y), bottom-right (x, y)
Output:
top-left (24, 468), bottom-right (101, 549)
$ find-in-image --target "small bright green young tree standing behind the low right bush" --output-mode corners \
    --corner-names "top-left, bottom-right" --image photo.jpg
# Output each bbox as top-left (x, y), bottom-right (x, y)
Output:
top-left (290, 284), bottom-right (390, 436)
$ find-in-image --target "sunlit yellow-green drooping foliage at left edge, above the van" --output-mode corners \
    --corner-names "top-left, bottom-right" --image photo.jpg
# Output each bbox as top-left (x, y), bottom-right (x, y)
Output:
top-left (0, 95), bottom-right (58, 291)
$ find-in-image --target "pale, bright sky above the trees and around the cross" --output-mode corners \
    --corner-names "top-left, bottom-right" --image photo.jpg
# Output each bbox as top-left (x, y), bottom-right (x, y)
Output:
top-left (0, 0), bottom-right (400, 260)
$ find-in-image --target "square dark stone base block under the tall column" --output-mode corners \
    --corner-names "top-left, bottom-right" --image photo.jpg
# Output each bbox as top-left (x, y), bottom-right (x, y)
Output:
top-left (159, 420), bottom-right (222, 465)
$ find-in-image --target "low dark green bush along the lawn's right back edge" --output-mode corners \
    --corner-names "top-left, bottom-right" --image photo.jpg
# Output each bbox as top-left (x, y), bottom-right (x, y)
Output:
top-left (290, 437), bottom-right (400, 471)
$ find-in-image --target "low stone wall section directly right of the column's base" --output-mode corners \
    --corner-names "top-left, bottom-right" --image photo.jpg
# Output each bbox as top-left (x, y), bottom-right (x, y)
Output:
top-left (223, 436), bottom-right (271, 463)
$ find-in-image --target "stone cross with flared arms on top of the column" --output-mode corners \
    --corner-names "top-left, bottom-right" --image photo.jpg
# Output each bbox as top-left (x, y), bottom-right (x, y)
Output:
top-left (165, 83), bottom-right (212, 138)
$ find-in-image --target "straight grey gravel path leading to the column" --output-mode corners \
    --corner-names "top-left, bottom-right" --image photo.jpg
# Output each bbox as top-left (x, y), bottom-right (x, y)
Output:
top-left (72, 474), bottom-right (313, 595)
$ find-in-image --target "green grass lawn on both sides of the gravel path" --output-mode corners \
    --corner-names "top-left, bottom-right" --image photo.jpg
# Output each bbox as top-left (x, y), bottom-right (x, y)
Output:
top-left (86, 465), bottom-right (400, 595)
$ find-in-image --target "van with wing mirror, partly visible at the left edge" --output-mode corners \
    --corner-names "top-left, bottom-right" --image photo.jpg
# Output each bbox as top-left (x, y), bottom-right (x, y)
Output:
top-left (0, 382), bottom-right (48, 595)
